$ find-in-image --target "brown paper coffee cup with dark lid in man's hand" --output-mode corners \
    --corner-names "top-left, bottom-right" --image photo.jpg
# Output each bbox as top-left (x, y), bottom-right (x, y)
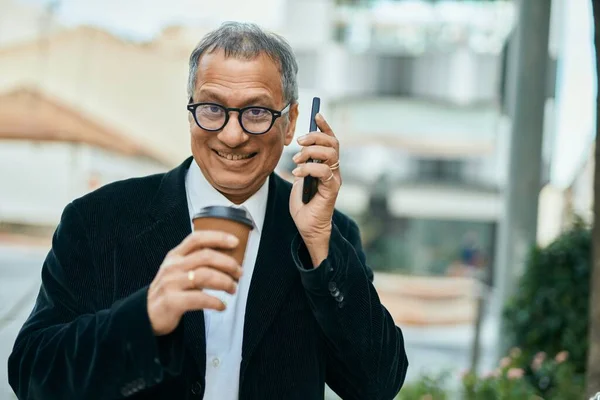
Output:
top-left (193, 206), bottom-right (254, 265)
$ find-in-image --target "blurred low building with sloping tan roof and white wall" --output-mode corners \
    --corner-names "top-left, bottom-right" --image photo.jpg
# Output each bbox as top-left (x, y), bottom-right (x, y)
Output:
top-left (0, 89), bottom-right (166, 232)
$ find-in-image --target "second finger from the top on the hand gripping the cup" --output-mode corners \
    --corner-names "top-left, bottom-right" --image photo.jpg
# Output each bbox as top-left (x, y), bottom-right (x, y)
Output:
top-left (164, 249), bottom-right (242, 280)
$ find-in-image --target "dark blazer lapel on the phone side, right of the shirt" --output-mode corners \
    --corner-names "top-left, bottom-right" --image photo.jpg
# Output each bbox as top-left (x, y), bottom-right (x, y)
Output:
top-left (240, 174), bottom-right (298, 387)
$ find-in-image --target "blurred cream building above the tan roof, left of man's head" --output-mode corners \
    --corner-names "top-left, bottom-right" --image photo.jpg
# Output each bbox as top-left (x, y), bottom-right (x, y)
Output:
top-left (0, 27), bottom-right (189, 165)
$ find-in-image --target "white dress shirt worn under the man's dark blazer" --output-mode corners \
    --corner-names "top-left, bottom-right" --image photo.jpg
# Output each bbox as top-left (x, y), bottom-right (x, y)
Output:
top-left (185, 161), bottom-right (269, 400)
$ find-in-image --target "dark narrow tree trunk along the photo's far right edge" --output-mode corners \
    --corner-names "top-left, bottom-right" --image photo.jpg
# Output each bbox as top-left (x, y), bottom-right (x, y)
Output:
top-left (587, 0), bottom-right (600, 396)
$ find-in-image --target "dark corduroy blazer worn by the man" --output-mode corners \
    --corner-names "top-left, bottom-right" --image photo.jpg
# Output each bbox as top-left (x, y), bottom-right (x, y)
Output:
top-left (8, 158), bottom-right (408, 400)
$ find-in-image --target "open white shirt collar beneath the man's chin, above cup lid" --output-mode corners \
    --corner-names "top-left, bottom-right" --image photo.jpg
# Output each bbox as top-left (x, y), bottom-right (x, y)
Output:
top-left (185, 160), bottom-right (270, 232)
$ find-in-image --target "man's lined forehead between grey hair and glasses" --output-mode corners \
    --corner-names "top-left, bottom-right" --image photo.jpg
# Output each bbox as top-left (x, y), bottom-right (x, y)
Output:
top-left (194, 49), bottom-right (283, 106)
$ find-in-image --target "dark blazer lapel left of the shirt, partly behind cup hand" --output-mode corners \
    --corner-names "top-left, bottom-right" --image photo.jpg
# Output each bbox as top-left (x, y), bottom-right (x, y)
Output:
top-left (117, 157), bottom-right (206, 371)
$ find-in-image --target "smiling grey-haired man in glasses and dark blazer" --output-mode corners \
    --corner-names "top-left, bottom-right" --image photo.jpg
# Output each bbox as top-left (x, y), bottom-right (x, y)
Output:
top-left (9, 23), bottom-right (408, 400)
